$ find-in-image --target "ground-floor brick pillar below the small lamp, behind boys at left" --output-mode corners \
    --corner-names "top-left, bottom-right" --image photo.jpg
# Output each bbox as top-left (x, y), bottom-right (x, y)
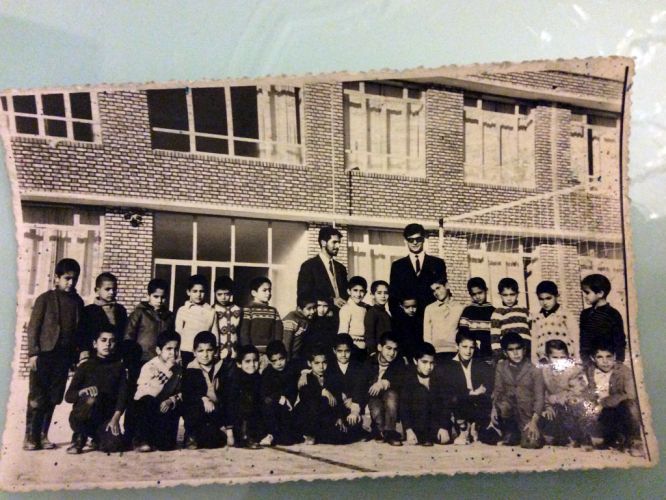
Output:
top-left (103, 208), bottom-right (153, 312)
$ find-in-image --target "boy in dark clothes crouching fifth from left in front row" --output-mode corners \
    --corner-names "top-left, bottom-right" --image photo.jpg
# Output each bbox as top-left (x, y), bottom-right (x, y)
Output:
top-left (260, 340), bottom-right (300, 446)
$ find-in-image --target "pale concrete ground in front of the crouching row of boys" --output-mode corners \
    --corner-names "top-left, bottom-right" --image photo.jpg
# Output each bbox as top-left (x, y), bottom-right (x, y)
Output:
top-left (0, 380), bottom-right (649, 490)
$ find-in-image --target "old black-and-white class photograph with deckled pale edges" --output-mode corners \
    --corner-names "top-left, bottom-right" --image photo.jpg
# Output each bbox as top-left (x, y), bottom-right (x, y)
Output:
top-left (0, 57), bottom-right (658, 490)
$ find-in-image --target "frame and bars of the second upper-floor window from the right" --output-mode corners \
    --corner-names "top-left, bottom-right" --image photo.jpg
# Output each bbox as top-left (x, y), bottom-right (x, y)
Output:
top-left (463, 93), bottom-right (537, 189)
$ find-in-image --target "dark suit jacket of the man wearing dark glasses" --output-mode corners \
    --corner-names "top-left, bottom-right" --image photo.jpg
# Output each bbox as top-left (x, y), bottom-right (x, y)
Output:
top-left (389, 254), bottom-right (446, 316)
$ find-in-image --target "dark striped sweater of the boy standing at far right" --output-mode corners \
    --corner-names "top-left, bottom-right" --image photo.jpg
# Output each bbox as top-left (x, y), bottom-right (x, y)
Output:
top-left (580, 304), bottom-right (627, 362)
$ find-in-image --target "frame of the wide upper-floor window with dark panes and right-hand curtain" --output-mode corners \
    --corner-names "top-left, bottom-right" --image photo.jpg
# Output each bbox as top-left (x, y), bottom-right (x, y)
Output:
top-left (146, 84), bottom-right (305, 165)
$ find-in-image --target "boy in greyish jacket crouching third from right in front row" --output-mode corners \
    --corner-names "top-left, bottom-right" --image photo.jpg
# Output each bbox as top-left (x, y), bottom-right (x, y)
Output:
top-left (491, 332), bottom-right (544, 448)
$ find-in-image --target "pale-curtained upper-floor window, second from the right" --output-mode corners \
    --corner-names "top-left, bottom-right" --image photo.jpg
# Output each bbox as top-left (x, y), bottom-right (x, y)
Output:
top-left (464, 97), bottom-right (535, 188)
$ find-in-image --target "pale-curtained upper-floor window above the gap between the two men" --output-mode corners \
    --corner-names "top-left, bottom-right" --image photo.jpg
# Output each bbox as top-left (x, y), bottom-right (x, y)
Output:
top-left (344, 82), bottom-right (425, 177)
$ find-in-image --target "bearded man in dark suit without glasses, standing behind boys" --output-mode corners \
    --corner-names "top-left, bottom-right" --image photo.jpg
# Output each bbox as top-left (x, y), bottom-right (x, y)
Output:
top-left (297, 226), bottom-right (349, 316)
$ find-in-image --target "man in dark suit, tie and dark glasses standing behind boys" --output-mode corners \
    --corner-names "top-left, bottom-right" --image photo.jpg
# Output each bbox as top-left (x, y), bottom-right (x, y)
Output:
top-left (389, 224), bottom-right (446, 318)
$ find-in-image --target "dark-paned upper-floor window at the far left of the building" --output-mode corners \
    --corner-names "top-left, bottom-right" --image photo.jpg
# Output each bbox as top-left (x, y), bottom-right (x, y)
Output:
top-left (0, 92), bottom-right (99, 142)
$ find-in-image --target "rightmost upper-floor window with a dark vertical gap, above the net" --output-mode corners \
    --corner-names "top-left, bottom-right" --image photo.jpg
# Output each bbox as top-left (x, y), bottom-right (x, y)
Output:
top-left (571, 112), bottom-right (620, 191)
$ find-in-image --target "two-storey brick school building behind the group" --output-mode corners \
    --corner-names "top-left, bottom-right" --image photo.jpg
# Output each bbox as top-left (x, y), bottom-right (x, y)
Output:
top-left (1, 59), bottom-right (624, 376)
